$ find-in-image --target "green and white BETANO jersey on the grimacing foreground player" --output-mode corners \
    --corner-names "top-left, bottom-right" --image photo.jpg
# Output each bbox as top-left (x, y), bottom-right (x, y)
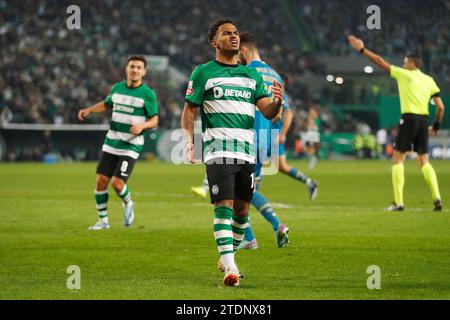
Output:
top-left (185, 61), bottom-right (268, 163)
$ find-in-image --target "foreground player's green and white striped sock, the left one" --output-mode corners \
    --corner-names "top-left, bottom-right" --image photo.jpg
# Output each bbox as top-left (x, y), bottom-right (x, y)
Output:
top-left (214, 207), bottom-right (234, 256)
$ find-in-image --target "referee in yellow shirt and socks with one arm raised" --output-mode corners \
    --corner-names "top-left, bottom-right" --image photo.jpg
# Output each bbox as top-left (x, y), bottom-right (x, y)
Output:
top-left (348, 35), bottom-right (444, 211)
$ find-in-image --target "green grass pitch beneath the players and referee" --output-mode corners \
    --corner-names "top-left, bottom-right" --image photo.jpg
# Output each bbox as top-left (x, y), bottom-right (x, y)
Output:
top-left (0, 161), bottom-right (450, 300)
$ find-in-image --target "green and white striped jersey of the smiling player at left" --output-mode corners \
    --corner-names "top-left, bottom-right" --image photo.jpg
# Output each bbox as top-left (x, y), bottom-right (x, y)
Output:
top-left (102, 81), bottom-right (158, 159)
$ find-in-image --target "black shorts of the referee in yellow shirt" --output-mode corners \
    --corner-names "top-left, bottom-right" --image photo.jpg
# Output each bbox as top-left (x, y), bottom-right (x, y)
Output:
top-left (394, 113), bottom-right (428, 155)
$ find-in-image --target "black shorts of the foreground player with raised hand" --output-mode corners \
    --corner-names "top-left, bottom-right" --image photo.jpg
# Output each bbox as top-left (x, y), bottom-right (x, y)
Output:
top-left (206, 160), bottom-right (255, 203)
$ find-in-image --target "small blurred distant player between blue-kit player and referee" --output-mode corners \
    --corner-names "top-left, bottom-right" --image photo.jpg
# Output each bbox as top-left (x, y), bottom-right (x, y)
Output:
top-left (305, 106), bottom-right (320, 170)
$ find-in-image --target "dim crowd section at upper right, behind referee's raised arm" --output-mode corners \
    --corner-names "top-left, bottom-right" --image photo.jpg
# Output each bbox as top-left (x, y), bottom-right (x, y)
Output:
top-left (296, 0), bottom-right (450, 81)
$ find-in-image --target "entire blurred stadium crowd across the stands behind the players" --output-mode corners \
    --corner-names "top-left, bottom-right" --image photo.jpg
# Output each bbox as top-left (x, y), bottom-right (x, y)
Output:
top-left (0, 0), bottom-right (450, 128)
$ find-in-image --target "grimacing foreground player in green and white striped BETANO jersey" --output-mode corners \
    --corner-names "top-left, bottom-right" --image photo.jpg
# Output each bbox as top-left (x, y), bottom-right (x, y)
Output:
top-left (181, 19), bottom-right (283, 286)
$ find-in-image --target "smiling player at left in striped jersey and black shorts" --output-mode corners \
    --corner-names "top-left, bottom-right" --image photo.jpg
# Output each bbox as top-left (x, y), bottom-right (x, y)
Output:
top-left (78, 56), bottom-right (158, 230)
